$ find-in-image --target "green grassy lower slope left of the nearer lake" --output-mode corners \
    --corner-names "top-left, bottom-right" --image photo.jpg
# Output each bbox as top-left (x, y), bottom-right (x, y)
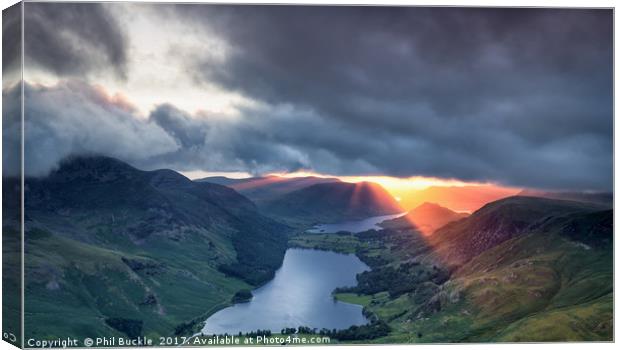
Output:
top-left (25, 230), bottom-right (248, 338)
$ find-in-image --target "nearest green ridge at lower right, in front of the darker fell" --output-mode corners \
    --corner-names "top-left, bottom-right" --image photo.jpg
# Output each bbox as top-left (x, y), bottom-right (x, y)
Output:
top-left (402, 211), bottom-right (613, 342)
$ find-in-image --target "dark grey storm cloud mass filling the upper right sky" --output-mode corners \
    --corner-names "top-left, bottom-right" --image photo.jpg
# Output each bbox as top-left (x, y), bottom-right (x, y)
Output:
top-left (170, 5), bottom-right (613, 189)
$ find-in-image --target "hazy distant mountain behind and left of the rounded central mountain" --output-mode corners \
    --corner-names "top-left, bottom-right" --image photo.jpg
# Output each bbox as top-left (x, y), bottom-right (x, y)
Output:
top-left (194, 176), bottom-right (340, 206)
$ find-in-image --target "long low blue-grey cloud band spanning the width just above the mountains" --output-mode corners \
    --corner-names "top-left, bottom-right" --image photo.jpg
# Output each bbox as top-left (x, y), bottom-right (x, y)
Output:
top-left (10, 78), bottom-right (611, 193)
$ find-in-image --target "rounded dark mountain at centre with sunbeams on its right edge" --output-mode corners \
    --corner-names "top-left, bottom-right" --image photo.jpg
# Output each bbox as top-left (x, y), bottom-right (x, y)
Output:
top-left (264, 182), bottom-right (402, 223)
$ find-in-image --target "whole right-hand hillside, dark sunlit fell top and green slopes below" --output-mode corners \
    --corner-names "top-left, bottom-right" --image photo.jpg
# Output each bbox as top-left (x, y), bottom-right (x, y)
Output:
top-left (371, 197), bottom-right (613, 342)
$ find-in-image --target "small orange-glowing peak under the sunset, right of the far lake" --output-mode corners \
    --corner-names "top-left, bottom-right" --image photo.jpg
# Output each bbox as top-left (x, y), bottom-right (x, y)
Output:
top-left (381, 202), bottom-right (468, 236)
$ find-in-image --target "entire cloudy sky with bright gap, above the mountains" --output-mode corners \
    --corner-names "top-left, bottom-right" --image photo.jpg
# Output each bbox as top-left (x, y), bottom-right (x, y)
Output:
top-left (3, 3), bottom-right (613, 191)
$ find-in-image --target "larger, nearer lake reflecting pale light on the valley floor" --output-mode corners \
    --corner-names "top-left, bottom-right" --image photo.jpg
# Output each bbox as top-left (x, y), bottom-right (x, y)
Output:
top-left (202, 248), bottom-right (370, 334)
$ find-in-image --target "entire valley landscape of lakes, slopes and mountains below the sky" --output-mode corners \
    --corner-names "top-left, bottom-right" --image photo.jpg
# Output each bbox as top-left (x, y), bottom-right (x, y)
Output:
top-left (10, 157), bottom-right (613, 343)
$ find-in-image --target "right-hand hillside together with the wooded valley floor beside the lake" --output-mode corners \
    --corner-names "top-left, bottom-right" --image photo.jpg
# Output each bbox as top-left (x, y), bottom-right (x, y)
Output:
top-left (291, 197), bottom-right (613, 344)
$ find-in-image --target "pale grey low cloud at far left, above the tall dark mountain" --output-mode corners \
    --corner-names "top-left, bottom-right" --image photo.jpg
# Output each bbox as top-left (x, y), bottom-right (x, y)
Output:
top-left (3, 81), bottom-right (181, 176)
